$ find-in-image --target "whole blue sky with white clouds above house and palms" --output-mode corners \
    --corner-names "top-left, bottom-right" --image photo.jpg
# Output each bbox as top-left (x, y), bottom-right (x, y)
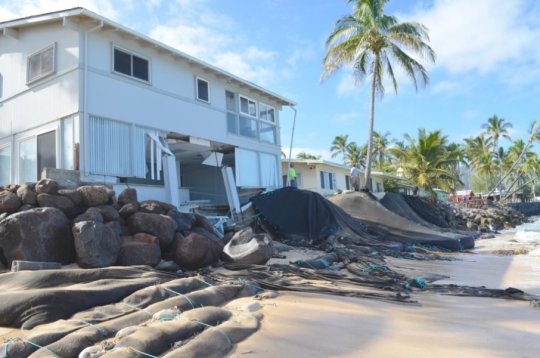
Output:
top-left (0, 0), bottom-right (540, 159)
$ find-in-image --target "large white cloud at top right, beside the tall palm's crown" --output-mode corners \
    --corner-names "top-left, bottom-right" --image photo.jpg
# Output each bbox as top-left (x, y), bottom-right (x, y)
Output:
top-left (408, 0), bottom-right (540, 75)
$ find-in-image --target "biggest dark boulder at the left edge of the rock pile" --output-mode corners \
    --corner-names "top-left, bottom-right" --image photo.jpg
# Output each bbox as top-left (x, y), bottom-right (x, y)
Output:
top-left (0, 208), bottom-right (75, 264)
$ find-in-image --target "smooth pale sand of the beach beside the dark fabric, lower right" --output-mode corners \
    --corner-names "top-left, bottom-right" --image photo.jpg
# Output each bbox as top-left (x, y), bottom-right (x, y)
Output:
top-left (231, 231), bottom-right (540, 357)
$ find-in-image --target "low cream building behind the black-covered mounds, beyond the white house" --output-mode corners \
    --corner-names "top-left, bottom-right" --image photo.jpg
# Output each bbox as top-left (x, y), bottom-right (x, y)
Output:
top-left (281, 159), bottom-right (400, 196)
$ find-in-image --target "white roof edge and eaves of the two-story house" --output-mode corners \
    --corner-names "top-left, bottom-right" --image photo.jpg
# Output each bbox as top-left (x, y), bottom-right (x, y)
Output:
top-left (0, 7), bottom-right (296, 106)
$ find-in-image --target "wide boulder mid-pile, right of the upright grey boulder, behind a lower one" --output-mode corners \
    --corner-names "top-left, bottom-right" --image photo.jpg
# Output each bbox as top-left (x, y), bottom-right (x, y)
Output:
top-left (127, 212), bottom-right (176, 247)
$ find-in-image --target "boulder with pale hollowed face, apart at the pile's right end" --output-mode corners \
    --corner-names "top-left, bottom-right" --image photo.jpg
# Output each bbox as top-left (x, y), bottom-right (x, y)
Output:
top-left (223, 228), bottom-right (273, 265)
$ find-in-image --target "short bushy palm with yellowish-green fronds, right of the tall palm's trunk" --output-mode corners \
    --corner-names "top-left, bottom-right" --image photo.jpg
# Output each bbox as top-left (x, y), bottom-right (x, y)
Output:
top-left (390, 129), bottom-right (463, 200)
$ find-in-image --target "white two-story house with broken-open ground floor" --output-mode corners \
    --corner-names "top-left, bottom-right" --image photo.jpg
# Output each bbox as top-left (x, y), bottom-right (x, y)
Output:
top-left (0, 8), bottom-right (294, 207)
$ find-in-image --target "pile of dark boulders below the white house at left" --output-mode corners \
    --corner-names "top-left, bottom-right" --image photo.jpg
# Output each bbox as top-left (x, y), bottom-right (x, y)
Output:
top-left (0, 179), bottom-right (231, 269)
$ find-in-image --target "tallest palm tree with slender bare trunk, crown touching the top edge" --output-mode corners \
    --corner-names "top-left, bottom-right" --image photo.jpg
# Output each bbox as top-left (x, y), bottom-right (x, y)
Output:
top-left (322, 0), bottom-right (435, 191)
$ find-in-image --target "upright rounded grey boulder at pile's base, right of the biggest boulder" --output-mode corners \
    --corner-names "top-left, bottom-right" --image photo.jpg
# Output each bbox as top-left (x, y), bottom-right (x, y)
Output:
top-left (72, 221), bottom-right (122, 268)
